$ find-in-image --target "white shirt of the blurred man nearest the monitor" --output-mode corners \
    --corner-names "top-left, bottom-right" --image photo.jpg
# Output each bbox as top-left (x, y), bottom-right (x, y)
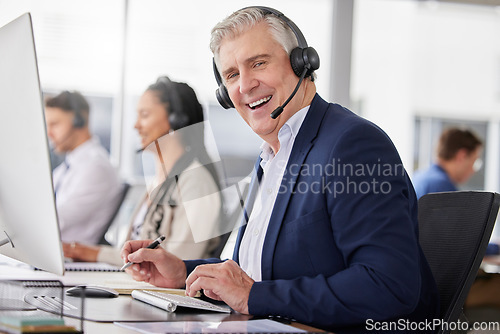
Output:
top-left (53, 138), bottom-right (122, 244)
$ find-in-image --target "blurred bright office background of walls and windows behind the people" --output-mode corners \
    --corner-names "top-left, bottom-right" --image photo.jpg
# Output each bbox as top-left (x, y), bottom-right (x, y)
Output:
top-left (0, 0), bottom-right (500, 211)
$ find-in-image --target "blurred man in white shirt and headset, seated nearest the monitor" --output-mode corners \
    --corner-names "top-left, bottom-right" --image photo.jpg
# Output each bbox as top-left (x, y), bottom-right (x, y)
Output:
top-left (45, 91), bottom-right (123, 244)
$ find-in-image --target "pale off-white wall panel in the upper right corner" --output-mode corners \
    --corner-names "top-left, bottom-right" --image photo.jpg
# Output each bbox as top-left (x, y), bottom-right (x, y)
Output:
top-left (414, 5), bottom-right (500, 119)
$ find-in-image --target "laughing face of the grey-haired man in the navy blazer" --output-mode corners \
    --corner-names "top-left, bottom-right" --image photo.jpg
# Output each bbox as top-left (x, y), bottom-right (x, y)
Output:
top-left (218, 22), bottom-right (302, 142)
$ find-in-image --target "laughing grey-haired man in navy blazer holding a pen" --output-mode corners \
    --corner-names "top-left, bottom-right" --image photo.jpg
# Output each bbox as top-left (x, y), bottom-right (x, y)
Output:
top-left (122, 7), bottom-right (438, 331)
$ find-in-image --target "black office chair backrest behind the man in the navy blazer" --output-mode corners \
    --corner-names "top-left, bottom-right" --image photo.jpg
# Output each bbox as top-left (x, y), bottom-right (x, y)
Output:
top-left (418, 191), bottom-right (500, 334)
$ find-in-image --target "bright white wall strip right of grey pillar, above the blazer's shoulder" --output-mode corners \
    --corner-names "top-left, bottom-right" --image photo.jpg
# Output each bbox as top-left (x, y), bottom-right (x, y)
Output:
top-left (351, 0), bottom-right (416, 168)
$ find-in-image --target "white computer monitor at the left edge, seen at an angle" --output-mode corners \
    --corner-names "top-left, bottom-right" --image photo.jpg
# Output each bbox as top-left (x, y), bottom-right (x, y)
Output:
top-left (0, 13), bottom-right (64, 275)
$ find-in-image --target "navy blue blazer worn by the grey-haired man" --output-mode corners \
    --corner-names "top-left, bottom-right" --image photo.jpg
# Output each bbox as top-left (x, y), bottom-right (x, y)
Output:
top-left (186, 94), bottom-right (439, 330)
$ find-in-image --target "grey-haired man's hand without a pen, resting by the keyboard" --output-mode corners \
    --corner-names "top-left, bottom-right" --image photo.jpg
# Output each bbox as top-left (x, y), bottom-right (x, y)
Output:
top-left (186, 260), bottom-right (254, 314)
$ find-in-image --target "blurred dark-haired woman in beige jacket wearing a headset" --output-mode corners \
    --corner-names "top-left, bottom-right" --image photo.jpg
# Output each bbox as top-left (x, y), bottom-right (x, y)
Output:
top-left (63, 77), bottom-right (222, 265)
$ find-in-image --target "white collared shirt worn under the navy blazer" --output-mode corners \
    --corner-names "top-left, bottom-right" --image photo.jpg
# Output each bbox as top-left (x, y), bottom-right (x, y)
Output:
top-left (239, 106), bottom-right (309, 281)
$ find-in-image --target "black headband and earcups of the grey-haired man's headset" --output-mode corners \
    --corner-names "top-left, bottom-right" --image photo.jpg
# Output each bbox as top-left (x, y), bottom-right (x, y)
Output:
top-left (212, 6), bottom-right (319, 109)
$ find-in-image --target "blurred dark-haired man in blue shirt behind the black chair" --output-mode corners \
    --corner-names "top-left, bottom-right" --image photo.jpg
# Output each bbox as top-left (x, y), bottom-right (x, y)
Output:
top-left (413, 128), bottom-right (483, 198)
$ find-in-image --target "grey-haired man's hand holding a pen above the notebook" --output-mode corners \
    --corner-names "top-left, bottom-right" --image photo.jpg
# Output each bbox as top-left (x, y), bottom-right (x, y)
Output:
top-left (120, 240), bottom-right (187, 288)
